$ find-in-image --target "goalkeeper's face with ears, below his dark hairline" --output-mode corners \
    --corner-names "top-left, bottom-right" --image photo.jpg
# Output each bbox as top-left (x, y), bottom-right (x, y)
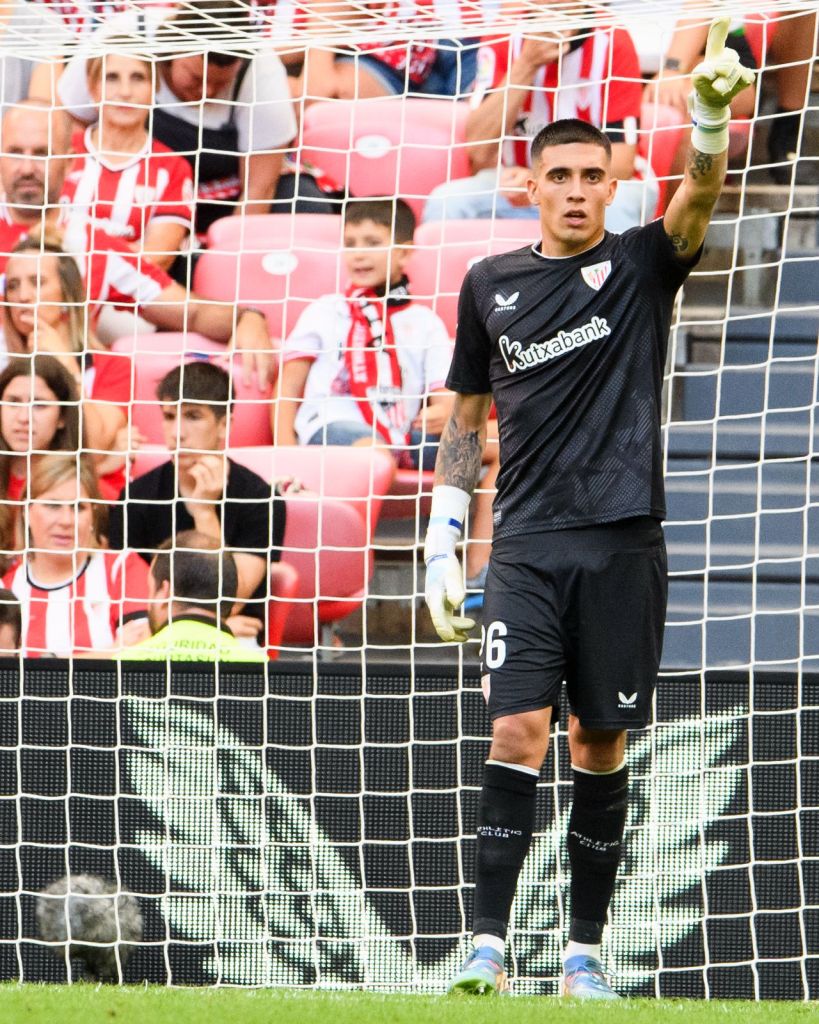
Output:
top-left (526, 142), bottom-right (617, 256)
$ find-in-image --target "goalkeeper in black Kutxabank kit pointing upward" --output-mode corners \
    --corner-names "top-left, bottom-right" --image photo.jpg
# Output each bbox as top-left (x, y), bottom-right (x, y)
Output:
top-left (424, 18), bottom-right (753, 999)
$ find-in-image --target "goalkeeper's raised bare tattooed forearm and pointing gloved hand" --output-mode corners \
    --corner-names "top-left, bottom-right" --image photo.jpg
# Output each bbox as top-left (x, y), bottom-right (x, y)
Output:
top-left (663, 17), bottom-right (753, 260)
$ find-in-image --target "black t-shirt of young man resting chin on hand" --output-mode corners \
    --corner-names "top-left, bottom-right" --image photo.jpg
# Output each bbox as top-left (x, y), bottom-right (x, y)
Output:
top-left (107, 459), bottom-right (285, 622)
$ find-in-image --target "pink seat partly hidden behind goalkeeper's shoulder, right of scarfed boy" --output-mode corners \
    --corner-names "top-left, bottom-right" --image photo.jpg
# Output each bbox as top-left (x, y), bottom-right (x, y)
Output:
top-left (407, 220), bottom-right (541, 336)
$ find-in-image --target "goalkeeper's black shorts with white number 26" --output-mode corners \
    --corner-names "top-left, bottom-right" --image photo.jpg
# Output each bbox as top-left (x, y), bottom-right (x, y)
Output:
top-left (481, 516), bottom-right (667, 730)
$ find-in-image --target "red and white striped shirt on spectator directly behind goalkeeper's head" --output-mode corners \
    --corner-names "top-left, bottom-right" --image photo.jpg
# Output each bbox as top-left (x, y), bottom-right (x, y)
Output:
top-left (471, 27), bottom-right (643, 167)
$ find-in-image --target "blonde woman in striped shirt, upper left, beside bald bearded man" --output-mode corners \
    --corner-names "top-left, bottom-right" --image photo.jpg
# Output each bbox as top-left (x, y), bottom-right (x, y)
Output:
top-left (61, 47), bottom-right (193, 269)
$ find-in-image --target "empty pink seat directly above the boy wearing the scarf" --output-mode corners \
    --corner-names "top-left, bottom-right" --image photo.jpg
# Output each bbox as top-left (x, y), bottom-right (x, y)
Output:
top-left (301, 96), bottom-right (470, 215)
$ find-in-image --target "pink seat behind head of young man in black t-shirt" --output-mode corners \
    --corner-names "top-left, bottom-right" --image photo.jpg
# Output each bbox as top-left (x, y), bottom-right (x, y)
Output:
top-left (114, 348), bottom-right (273, 446)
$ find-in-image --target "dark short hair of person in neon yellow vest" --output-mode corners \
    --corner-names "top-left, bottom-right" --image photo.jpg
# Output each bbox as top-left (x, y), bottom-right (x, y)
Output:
top-left (150, 529), bottom-right (239, 614)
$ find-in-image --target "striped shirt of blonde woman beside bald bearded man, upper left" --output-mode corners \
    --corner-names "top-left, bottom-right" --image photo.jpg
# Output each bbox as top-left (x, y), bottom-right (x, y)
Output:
top-left (60, 128), bottom-right (193, 242)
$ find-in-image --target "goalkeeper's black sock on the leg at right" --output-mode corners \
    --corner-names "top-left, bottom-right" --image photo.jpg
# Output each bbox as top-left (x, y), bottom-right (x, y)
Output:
top-left (566, 765), bottom-right (629, 944)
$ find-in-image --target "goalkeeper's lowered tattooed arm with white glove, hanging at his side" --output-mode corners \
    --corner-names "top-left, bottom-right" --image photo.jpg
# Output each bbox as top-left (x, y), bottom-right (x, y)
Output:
top-left (424, 394), bottom-right (491, 642)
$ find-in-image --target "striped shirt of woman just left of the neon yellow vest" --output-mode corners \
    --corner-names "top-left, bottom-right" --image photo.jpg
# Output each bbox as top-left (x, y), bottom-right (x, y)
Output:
top-left (3, 551), bottom-right (148, 657)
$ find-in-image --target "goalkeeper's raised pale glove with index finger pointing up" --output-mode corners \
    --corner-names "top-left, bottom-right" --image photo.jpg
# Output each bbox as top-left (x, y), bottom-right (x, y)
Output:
top-left (689, 17), bottom-right (755, 156)
